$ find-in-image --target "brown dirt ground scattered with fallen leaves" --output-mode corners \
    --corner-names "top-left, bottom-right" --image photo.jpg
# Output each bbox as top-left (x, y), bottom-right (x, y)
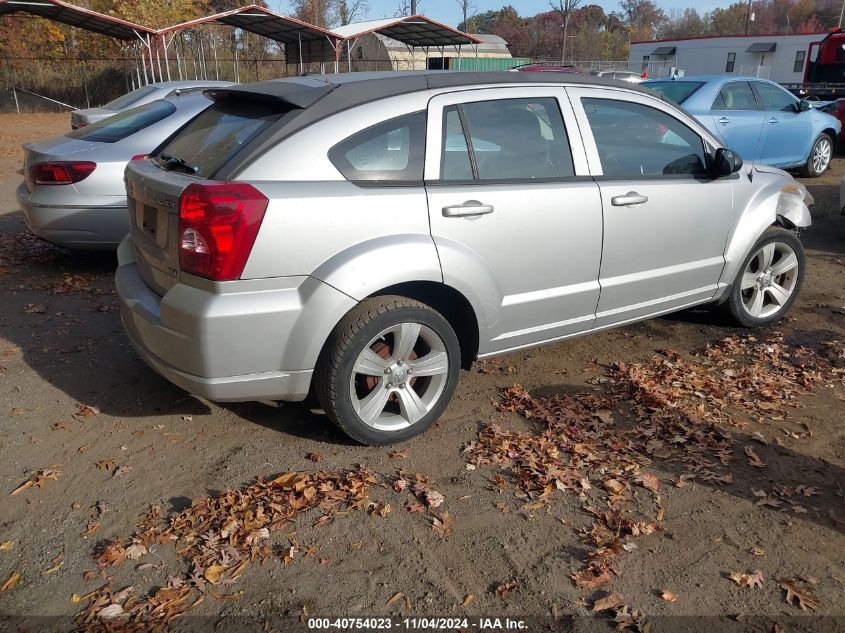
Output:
top-left (0, 115), bottom-right (845, 632)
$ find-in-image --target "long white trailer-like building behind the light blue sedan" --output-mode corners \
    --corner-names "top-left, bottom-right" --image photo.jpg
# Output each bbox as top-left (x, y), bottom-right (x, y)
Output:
top-left (628, 33), bottom-right (827, 83)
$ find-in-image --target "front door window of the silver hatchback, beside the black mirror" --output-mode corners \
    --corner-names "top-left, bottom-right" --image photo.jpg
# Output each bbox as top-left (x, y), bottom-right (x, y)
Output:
top-left (581, 98), bottom-right (707, 179)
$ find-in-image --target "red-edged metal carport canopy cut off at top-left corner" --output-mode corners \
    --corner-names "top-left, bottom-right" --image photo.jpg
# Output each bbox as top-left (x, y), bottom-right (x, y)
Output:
top-left (0, 0), bottom-right (155, 41)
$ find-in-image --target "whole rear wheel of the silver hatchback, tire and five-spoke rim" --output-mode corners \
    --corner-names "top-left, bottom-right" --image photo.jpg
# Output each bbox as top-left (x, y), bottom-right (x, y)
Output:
top-left (315, 297), bottom-right (460, 445)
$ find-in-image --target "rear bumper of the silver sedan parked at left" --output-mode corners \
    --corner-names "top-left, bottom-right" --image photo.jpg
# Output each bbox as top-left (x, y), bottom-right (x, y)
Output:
top-left (17, 185), bottom-right (129, 250)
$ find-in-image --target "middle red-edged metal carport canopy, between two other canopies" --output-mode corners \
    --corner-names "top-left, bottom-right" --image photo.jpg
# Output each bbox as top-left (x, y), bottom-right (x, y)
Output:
top-left (158, 5), bottom-right (343, 64)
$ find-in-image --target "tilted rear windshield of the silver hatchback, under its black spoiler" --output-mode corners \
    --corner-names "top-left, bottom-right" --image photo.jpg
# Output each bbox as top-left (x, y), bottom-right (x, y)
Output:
top-left (158, 99), bottom-right (287, 178)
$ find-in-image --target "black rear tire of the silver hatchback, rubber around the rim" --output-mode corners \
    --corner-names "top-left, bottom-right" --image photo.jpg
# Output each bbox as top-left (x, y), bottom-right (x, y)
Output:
top-left (314, 296), bottom-right (461, 446)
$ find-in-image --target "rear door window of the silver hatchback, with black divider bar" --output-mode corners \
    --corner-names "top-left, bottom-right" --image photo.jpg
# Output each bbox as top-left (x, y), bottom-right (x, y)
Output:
top-left (441, 97), bottom-right (575, 181)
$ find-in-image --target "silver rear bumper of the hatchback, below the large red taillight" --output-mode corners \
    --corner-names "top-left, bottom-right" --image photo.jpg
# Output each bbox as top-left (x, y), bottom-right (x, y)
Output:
top-left (115, 235), bottom-right (354, 402)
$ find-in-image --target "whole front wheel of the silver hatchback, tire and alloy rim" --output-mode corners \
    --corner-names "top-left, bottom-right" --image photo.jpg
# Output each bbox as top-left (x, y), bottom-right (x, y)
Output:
top-left (728, 227), bottom-right (805, 327)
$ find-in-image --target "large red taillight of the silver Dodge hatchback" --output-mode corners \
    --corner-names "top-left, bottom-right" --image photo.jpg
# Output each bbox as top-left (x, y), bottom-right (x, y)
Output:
top-left (179, 182), bottom-right (269, 281)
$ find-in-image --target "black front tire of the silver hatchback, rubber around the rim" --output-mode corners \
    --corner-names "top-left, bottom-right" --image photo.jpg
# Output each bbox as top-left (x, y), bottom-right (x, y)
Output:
top-left (725, 226), bottom-right (806, 327)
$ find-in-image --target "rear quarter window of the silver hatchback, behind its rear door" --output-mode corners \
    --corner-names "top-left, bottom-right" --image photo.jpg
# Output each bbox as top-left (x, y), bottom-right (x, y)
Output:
top-left (329, 112), bottom-right (426, 185)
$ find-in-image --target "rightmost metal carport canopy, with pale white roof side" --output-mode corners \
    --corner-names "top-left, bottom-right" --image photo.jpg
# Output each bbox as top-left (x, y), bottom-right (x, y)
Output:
top-left (335, 15), bottom-right (481, 48)
